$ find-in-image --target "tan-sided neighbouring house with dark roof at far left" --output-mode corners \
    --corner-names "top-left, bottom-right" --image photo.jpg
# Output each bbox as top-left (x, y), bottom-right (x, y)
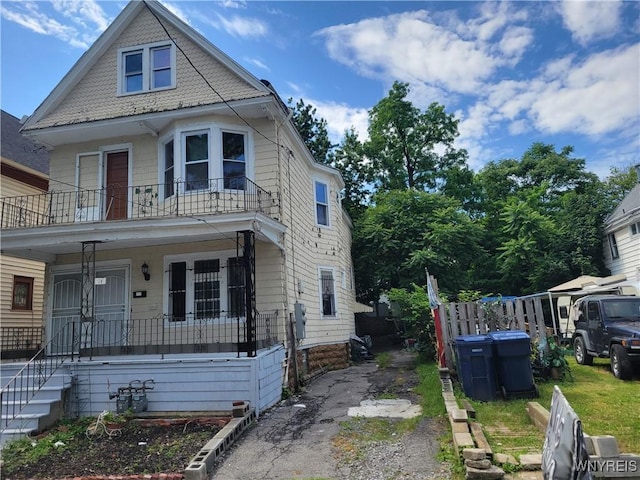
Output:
top-left (0, 110), bottom-right (49, 359)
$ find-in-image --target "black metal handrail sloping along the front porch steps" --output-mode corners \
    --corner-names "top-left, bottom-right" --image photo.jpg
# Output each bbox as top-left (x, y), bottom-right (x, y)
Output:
top-left (0, 323), bottom-right (76, 431)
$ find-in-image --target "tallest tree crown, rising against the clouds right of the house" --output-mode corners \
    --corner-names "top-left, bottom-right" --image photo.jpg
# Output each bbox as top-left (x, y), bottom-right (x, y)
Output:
top-left (365, 82), bottom-right (466, 191)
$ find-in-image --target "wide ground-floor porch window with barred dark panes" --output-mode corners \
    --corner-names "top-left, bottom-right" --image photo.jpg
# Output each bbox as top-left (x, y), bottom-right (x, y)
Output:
top-left (166, 255), bottom-right (245, 323)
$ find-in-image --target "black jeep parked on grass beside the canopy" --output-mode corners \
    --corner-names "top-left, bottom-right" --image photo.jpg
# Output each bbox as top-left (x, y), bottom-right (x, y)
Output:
top-left (572, 295), bottom-right (640, 379)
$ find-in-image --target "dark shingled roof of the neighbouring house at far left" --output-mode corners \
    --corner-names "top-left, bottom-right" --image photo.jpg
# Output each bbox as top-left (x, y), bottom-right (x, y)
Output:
top-left (0, 110), bottom-right (49, 175)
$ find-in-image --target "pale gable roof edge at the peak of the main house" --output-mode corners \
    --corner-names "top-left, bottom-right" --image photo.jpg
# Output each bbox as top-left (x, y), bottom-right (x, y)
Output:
top-left (23, 0), bottom-right (277, 131)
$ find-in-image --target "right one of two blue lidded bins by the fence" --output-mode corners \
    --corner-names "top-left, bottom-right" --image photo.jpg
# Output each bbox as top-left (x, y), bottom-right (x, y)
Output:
top-left (489, 330), bottom-right (538, 399)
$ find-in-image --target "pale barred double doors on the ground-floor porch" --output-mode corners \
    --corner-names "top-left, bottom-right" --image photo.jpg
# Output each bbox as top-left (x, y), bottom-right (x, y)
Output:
top-left (49, 268), bottom-right (127, 355)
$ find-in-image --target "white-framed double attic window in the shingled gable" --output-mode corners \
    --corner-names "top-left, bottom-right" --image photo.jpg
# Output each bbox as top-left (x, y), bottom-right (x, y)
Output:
top-left (118, 43), bottom-right (176, 95)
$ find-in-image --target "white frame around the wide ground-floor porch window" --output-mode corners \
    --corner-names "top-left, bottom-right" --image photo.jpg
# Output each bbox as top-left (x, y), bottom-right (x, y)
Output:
top-left (162, 250), bottom-right (246, 326)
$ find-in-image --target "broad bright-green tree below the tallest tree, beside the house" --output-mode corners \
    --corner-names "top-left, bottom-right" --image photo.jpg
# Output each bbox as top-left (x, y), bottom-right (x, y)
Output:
top-left (352, 190), bottom-right (480, 301)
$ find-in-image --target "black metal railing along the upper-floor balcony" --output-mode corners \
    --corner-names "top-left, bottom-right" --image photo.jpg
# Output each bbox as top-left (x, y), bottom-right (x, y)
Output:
top-left (0, 177), bottom-right (273, 229)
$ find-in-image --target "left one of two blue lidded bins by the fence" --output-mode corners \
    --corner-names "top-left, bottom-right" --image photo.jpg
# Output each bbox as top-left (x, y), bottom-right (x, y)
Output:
top-left (455, 335), bottom-right (497, 402)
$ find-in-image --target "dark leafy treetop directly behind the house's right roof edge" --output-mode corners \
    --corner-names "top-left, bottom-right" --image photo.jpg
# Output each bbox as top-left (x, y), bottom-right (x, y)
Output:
top-left (288, 98), bottom-right (332, 164)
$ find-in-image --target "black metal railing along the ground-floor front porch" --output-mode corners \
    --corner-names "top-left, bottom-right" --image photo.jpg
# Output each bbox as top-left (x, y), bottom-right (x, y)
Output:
top-left (49, 311), bottom-right (278, 358)
